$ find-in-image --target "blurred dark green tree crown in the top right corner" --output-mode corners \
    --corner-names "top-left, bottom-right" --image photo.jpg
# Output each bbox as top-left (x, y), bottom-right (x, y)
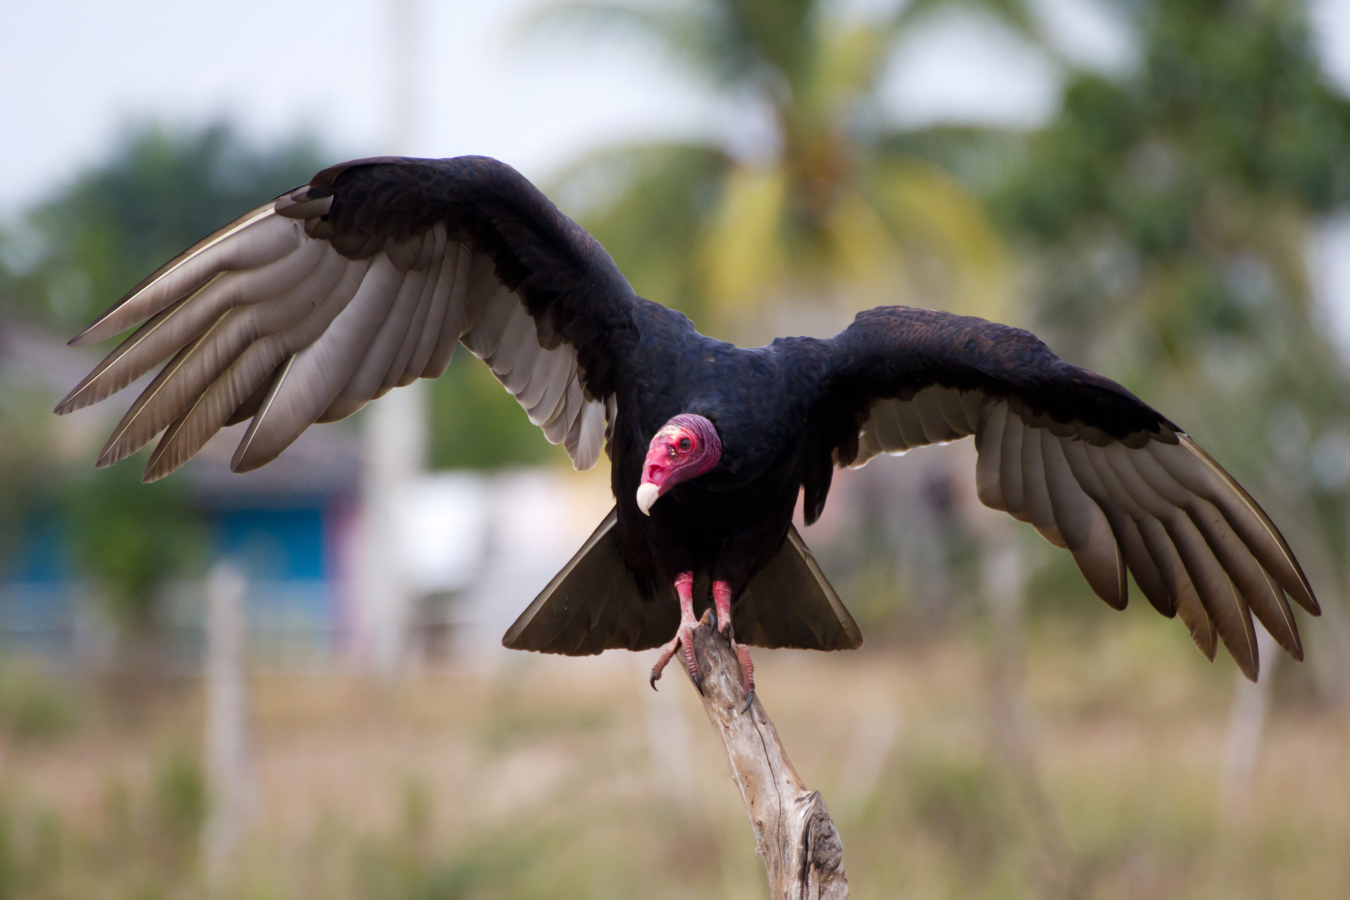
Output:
top-left (995, 0), bottom-right (1350, 299)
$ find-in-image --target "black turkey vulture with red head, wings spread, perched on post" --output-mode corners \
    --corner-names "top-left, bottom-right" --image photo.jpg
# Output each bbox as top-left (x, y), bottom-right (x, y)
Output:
top-left (57, 157), bottom-right (1319, 688)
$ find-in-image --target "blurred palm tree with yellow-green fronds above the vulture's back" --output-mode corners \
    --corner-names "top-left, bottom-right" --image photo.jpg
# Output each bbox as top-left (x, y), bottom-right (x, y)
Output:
top-left (532, 0), bottom-right (1035, 336)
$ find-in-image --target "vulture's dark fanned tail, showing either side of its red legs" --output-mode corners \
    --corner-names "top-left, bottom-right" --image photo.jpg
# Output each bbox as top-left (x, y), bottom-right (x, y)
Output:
top-left (502, 510), bottom-right (863, 656)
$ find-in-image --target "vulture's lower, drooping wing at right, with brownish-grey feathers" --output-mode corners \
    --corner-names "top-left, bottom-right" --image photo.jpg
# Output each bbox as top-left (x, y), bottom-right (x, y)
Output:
top-left (821, 308), bottom-right (1319, 679)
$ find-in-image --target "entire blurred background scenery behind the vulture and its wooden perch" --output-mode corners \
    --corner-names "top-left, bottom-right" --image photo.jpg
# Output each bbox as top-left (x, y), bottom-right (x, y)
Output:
top-left (0, 0), bottom-right (1350, 900)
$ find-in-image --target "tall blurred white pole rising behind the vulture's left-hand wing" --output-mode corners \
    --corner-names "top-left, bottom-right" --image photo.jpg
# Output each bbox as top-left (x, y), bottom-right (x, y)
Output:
top-left (360, 0), bottom-right (427, 677)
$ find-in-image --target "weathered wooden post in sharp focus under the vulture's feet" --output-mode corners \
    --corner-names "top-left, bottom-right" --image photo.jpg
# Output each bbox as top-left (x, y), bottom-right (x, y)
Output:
top-left (680, 611), bottom-right (848, 900)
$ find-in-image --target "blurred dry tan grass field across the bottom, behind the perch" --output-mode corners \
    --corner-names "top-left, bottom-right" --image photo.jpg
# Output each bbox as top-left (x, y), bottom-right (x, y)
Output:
top-left (0, 614), bottom-right (1350, 900)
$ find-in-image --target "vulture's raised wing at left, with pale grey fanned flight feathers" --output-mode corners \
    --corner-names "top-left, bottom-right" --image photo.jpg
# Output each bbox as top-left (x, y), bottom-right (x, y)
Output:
top-left (57, 157), bottom-right (633, 480)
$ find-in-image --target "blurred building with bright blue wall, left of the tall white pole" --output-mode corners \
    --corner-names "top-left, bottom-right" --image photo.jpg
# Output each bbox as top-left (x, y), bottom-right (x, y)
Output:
top-left (0, 321), bottom-right (362, 667)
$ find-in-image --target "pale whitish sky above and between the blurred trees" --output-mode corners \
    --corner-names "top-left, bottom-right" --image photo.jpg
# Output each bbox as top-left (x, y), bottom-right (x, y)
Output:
top-left (0, 0), bottom-right (1350, 335)
